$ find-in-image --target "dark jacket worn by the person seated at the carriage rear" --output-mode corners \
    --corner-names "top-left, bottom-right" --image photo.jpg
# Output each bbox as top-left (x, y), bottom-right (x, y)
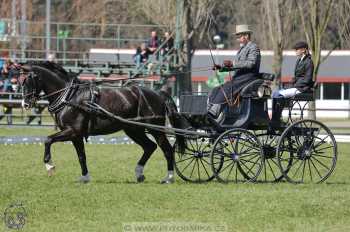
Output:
top-left (292, 54), bottom-right (314, 92)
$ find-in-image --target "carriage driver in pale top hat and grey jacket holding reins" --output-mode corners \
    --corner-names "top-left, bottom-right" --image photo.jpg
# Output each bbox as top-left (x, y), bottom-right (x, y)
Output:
top-left (208, 25), bottom-right (261, 123)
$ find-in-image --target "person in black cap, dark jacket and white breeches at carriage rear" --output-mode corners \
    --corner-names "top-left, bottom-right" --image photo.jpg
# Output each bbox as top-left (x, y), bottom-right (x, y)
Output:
top-left (271, 41), bottom-right (314, 128)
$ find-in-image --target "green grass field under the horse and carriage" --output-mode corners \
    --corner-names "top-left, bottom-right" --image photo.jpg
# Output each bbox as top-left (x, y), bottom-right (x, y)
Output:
top-left (0, 128), bottom-right (350, 232)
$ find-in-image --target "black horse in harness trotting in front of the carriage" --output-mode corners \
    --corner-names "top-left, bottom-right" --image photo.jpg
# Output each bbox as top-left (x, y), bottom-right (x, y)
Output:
top-left (20, 62), bottom-right (183, 183)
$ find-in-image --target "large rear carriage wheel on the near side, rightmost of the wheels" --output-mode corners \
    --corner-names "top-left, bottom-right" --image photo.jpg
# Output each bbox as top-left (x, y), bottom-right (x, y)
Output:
top-left (277, 120), bottom-right (337, 183)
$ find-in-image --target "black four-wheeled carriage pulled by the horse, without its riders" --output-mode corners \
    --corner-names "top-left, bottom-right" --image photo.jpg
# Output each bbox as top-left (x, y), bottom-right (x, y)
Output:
top-left (175, 74), bottom-right (337, 183)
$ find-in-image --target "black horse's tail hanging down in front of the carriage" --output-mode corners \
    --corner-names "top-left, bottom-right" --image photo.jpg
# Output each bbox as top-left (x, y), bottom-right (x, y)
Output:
top-left (160, 90), bottom-right (186, 153)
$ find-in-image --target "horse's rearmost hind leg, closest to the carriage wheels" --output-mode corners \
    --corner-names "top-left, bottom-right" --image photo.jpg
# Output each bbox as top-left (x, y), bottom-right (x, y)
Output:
top-left (151, 131), bottom-right (175, 184)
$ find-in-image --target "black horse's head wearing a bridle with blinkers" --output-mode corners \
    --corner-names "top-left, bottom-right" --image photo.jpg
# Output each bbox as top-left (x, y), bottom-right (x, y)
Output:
top-left (19, 65), bottom-right (42, 109)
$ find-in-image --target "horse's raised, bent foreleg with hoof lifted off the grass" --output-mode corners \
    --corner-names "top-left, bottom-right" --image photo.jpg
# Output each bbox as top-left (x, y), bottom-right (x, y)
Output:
top-left (44, 128), bottom-right (74, 176)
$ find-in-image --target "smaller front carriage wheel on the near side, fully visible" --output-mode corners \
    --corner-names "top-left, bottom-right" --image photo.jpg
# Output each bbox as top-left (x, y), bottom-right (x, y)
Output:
top-left (210, 129), bottom-right (264, 183)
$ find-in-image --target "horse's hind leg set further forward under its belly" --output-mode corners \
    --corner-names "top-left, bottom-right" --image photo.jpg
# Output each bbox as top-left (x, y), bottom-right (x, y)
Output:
top-left (124, 129), bottom-right (157, 182)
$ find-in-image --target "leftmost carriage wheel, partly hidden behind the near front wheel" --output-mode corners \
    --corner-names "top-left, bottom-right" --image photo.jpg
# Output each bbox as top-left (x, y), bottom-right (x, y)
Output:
top-left (175, 137), bottom-right (215, 183)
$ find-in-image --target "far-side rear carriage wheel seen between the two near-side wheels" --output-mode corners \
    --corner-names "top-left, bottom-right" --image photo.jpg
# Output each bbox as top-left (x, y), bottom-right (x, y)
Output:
top-left (254, 131), bottom-right (292, 182)
